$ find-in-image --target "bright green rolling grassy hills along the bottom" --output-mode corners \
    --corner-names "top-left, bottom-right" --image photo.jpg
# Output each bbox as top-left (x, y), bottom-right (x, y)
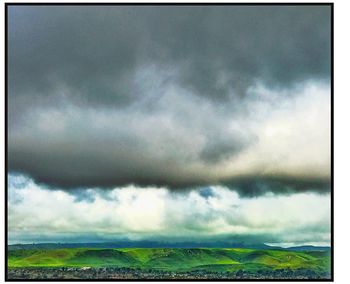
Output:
top-left (8, 248), bottom-right (330, 272)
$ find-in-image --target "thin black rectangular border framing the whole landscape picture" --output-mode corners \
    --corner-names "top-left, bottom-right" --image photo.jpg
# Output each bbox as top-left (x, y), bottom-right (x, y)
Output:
top-left (4, 2), bottom-right (334, 282)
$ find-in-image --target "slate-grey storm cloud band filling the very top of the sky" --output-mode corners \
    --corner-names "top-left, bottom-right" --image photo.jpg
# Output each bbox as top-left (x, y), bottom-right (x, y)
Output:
top-left (9, 6), bottom-right (330, 106)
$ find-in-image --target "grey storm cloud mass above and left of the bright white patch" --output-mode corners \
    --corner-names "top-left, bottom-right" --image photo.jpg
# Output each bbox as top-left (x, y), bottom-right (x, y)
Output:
top-left (8, 6), bottom-right (330, 192)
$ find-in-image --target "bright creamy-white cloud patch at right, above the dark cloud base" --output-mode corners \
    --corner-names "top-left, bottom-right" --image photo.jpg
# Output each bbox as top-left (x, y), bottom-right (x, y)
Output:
top-left (221, 83), bottom-right (331, 178)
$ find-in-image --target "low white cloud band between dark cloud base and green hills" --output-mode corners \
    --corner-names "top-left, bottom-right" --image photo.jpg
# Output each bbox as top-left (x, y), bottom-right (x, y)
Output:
top-left (8, 175), bottom-right (330, 245)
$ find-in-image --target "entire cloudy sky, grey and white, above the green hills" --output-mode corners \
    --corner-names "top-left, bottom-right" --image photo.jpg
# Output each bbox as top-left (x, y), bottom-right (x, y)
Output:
top-left (8, 5), bottom-right (331, 246)
